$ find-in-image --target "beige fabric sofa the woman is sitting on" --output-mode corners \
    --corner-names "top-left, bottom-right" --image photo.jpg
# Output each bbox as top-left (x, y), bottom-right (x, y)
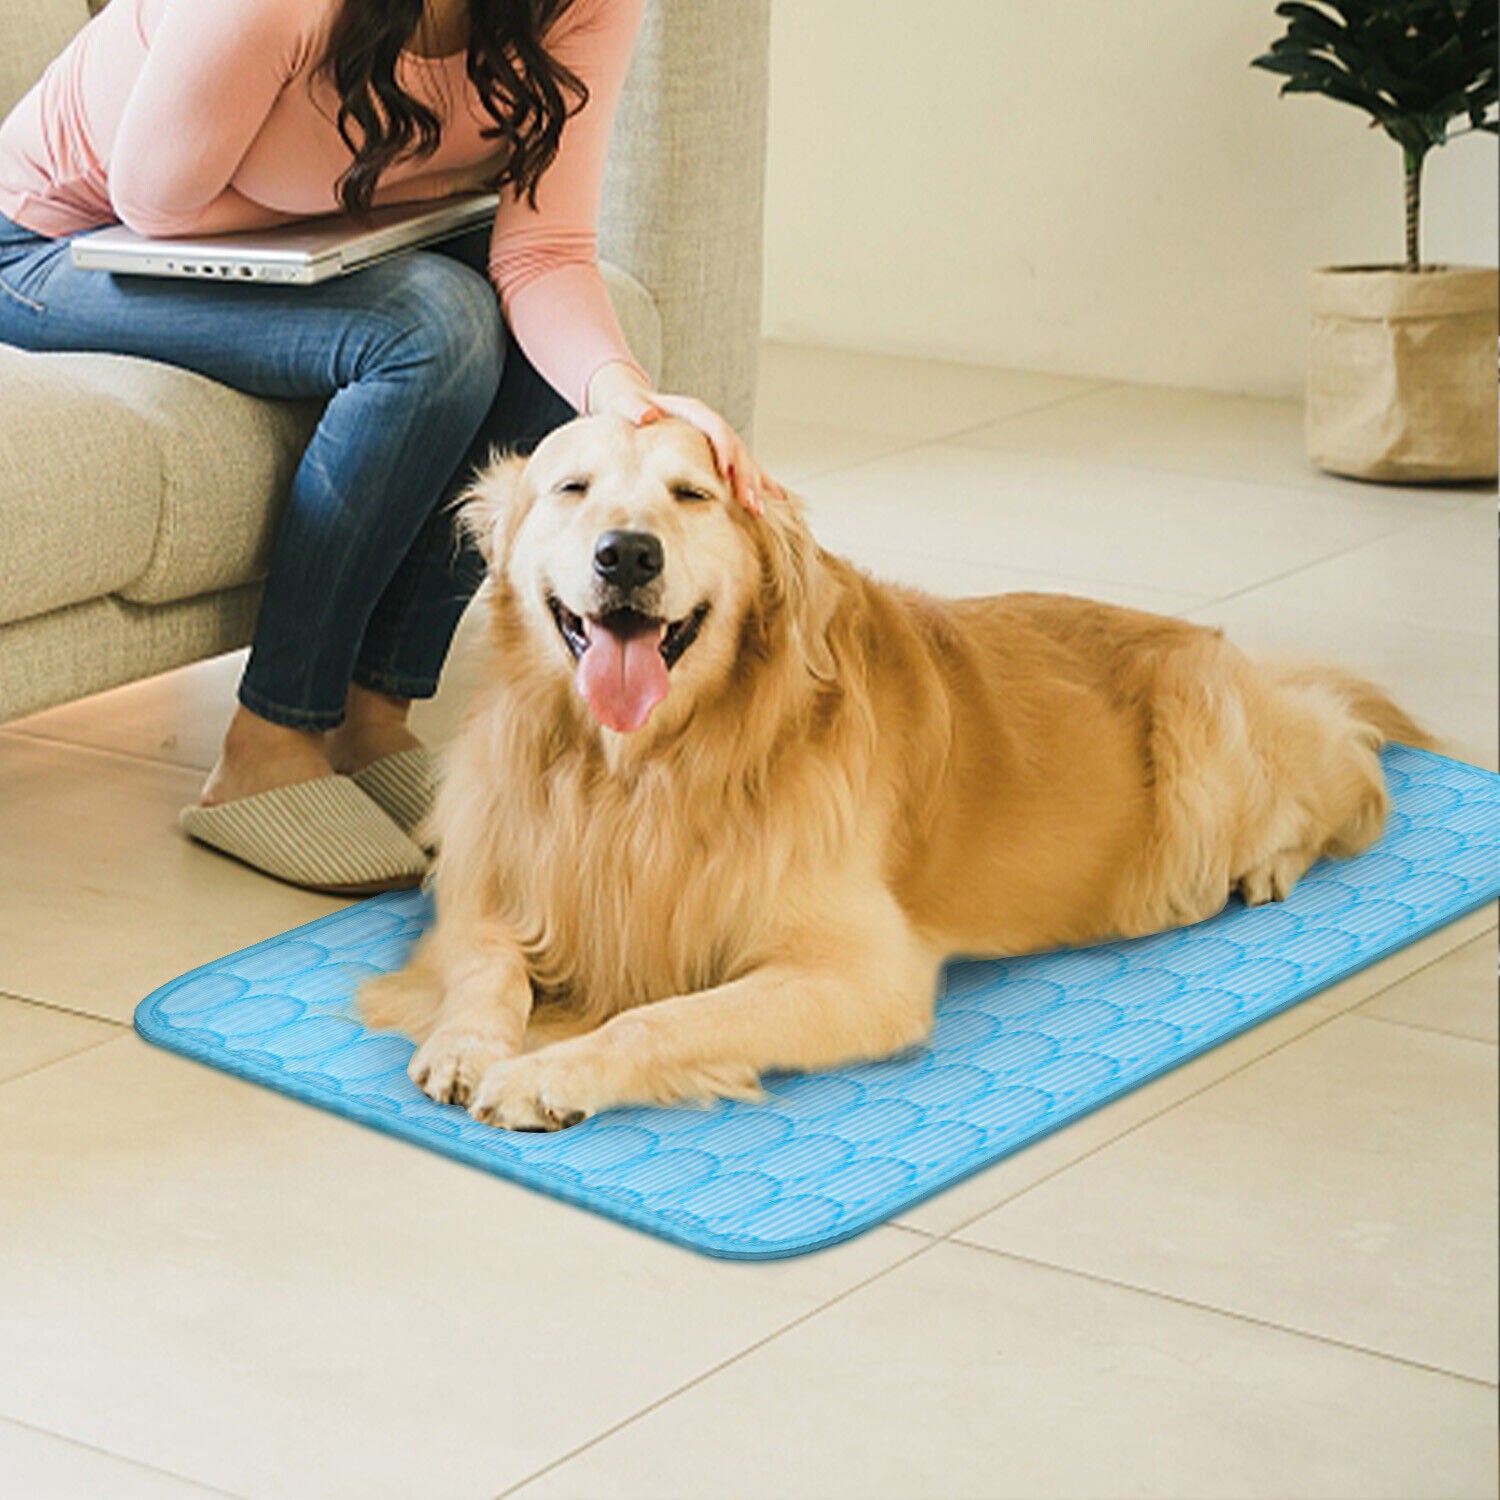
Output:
top-left (0, 0), bottom-right (770, 720)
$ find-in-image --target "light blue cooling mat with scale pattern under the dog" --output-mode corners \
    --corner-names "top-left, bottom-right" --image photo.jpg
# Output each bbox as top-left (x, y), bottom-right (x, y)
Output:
top-left (135, 747), bottom-right (1500, 1259)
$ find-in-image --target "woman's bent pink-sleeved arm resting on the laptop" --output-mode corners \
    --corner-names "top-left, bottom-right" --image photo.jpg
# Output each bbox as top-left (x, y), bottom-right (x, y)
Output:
top-left (108, 0), bottom-right (318, 236)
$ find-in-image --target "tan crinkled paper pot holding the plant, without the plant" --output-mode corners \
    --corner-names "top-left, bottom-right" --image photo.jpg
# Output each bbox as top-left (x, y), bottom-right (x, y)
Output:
top-left (1307, 266), bottom-right (1500, 483)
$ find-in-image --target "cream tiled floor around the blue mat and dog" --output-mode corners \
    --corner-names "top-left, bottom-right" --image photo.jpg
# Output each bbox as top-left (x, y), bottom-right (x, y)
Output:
top-left (0, 347), bottom-right (1497, 1500)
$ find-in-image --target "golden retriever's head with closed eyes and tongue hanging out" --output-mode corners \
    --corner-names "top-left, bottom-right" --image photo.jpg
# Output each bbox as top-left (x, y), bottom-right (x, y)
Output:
top-left (464, 417), bottom-right (834, 734)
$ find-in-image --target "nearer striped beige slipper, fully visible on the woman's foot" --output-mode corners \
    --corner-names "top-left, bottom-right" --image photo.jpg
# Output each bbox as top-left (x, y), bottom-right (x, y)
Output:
top-left (179, 776), bottom-right (428, 896)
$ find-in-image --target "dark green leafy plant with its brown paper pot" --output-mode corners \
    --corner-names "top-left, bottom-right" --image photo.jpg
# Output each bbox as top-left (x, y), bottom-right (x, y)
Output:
top-left (1251, 0), bottom-right (1500, 482)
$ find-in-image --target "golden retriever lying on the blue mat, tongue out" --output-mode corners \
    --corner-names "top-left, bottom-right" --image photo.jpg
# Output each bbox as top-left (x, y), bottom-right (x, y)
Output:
top-left (362, 417), bottom-right (1425, 1130)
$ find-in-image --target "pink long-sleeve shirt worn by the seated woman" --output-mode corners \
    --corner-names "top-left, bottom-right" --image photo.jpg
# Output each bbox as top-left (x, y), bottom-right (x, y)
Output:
top-left (0, 0), bottom-right (644, 408)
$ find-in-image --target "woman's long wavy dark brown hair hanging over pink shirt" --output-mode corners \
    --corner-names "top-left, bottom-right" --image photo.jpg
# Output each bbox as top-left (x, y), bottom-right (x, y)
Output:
top-left (318, 0), bottom-right (588, 215)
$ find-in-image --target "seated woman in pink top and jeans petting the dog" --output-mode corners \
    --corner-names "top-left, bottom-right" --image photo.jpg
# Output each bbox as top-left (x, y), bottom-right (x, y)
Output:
top-left (0, 0), bottom-right (780, 891)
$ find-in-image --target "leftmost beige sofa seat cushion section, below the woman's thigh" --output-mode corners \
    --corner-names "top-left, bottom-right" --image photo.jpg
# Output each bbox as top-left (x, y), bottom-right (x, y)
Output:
top-left (0, 344), bottom-right (162, 621)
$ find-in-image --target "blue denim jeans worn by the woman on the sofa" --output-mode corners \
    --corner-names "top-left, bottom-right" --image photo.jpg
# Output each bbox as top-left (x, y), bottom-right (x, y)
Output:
top-left (0, 216), bottom-right (573, 729)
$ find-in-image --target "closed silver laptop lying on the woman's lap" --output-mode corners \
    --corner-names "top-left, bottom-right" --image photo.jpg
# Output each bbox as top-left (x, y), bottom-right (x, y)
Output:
top-left (72, 194), bottom-right (500, 287)
